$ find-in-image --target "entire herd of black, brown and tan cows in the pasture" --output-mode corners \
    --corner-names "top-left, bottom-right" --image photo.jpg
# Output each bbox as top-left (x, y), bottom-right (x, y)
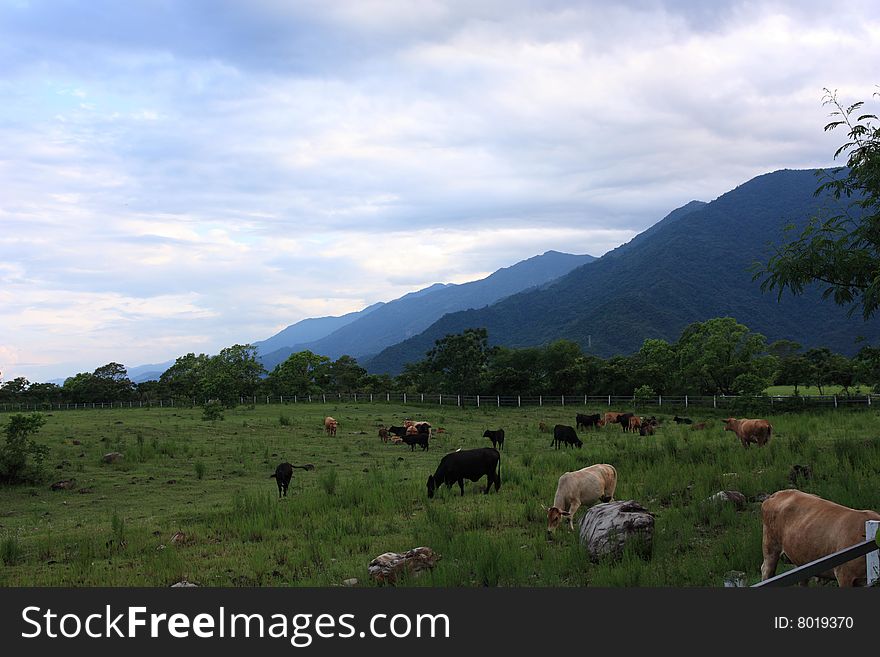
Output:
top-left (271, 412), bottom-right (880, 587)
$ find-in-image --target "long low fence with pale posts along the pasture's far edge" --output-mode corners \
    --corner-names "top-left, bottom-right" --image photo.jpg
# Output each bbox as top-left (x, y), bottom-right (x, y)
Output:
top-left (0, 392), bottom-right (877, 413)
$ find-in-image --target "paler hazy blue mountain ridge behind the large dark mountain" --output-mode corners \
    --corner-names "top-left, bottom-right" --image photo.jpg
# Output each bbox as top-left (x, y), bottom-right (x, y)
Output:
top-left (261, 251), bottom-right (595, 370)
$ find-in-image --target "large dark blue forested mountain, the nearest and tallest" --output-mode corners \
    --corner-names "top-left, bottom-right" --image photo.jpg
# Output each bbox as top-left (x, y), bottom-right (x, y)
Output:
top-left (365, 170), bottom-right (880, 374)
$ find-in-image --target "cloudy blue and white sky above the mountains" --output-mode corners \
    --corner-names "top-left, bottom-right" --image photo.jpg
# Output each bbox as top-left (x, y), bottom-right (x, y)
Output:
top-left (0, 0), bottom-right (880, 382)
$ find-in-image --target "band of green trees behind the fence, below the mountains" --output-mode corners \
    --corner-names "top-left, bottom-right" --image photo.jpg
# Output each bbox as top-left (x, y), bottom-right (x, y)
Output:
top-left (0, 317), bottom-right (880, 406)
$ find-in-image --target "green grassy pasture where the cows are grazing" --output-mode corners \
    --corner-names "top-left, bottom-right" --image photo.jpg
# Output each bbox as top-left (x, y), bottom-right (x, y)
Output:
top-left (0, 403), bottom-right (880, 587)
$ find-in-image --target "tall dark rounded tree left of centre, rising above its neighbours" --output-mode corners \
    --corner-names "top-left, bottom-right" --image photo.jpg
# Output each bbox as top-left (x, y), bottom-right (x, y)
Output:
top-left (426, 328), bottom-right (493, 394)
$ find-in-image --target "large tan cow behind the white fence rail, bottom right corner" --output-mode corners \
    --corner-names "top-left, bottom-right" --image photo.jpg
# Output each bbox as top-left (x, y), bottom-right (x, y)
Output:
top-left (761, 489), bottom-right (880, 587)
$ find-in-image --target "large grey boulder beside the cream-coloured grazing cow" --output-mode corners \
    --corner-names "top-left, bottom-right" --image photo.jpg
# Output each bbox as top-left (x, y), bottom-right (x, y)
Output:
top-left (580, 500), bottom-right (654, 561)
